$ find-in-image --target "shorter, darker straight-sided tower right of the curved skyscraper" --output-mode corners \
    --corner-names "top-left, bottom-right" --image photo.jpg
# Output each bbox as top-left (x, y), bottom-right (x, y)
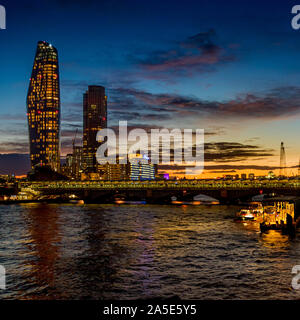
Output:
top-left (83, 86), bottom-right (107, 172)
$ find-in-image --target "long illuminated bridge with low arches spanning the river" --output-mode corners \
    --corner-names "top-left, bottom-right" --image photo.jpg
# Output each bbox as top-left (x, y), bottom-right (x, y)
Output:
top-left (18, 180), bottom-right (300, 203)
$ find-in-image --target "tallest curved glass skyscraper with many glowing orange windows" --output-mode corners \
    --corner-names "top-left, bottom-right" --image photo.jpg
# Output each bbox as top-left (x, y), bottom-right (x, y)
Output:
top-left (27, 41), bottom-right (60, 171)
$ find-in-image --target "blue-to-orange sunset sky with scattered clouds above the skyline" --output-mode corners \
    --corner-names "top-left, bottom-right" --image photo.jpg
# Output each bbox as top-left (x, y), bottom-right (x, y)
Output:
top-left (0, 0), bottom-right (300, 177)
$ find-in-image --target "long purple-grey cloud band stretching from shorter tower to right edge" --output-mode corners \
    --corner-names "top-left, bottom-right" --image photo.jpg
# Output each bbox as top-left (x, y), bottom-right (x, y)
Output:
top-left (109, 86), bottom-right (300, 120)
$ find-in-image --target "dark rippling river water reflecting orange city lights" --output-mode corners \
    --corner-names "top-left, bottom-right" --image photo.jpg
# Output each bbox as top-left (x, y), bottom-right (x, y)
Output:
top-left (0, 204), bottom-right (300, 299)
